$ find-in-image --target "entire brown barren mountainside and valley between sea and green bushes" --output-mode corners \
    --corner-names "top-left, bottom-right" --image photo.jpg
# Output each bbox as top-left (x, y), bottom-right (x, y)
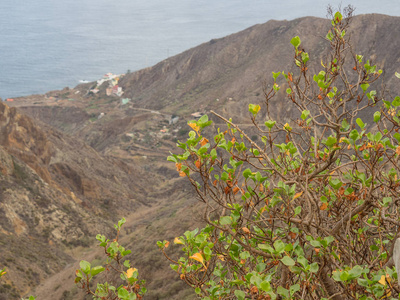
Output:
top-left (0, 14), bottom-right (400, 299)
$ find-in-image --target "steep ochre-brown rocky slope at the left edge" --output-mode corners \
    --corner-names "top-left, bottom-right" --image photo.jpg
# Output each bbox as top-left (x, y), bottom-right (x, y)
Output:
top-left (0, 103), bottom-right (151, 299)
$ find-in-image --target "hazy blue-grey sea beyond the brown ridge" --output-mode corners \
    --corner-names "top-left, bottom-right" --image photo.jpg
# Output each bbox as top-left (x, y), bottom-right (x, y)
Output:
top-left (0, 0), bottom-right (400, 99)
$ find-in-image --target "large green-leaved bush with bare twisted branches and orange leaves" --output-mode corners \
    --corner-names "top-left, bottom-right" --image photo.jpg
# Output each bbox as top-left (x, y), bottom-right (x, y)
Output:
top-left (158, 9), bottom-right (400, 300)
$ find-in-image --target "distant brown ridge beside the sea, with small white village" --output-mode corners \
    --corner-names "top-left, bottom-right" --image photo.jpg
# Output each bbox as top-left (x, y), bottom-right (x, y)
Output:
top-left (8, 14), bottom-right (400, 157)
